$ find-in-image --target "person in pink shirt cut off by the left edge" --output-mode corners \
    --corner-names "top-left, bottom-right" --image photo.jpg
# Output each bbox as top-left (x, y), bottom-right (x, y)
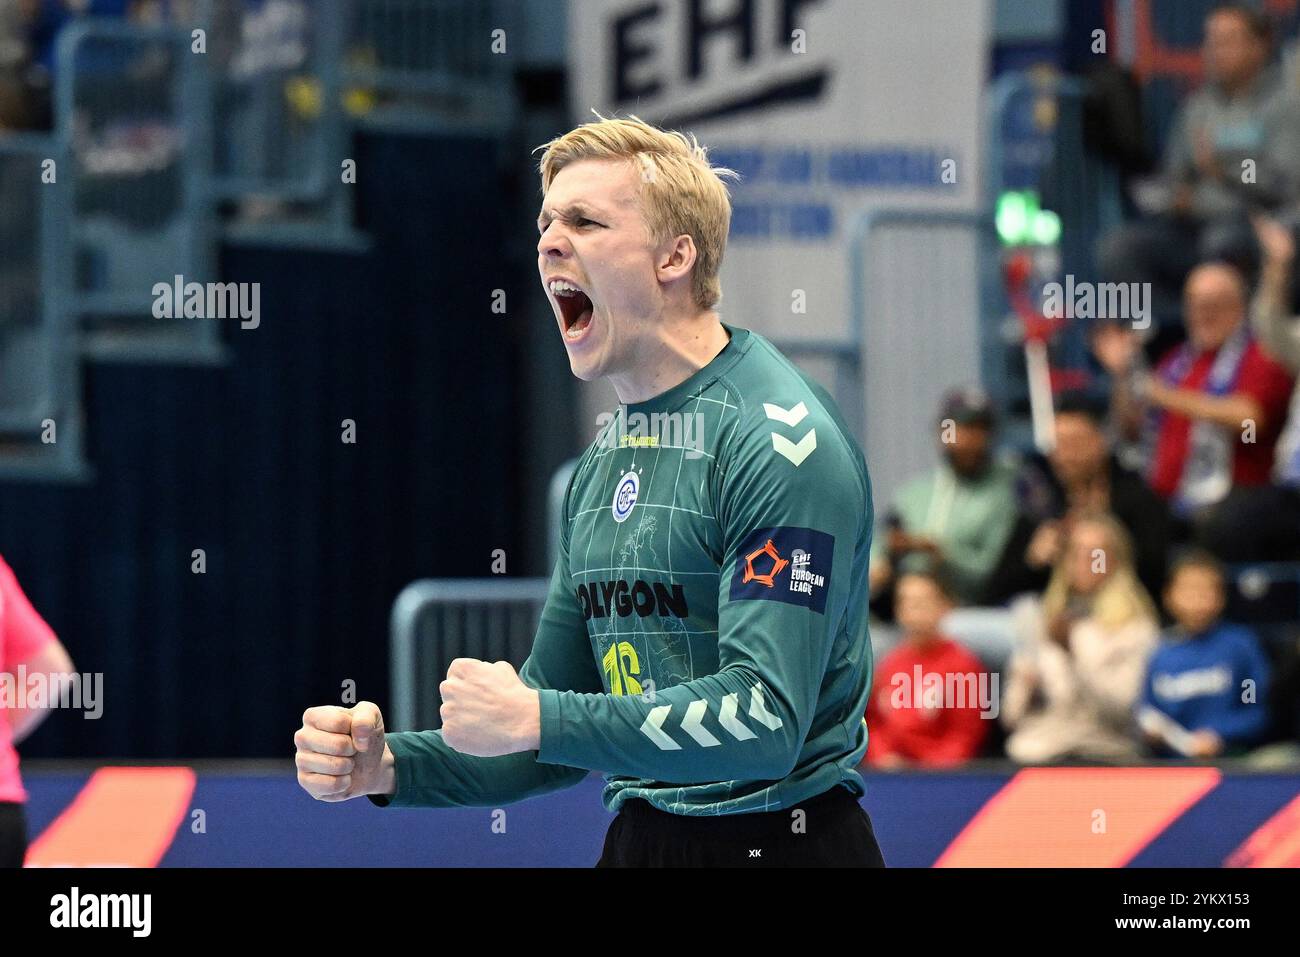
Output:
top-left (0, 558), bottom-right (73, 867)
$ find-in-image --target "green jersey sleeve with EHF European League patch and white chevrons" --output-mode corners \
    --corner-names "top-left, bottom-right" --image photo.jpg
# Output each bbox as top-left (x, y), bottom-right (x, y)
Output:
top-left (538, 403), bottom-right (870, 785)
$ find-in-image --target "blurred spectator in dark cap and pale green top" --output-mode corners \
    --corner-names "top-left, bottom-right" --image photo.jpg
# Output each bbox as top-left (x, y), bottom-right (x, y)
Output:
top-left (870, 389), bottom-right (1017, 605)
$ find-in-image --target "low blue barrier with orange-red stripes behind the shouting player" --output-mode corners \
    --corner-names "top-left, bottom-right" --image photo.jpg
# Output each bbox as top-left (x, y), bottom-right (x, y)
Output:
top-left (23, 762), bottom-right (1300, 867)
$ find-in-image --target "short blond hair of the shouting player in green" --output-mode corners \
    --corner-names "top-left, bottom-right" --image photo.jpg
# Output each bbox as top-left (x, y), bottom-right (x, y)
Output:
top-left (533, 111), bottom-right (740, 309)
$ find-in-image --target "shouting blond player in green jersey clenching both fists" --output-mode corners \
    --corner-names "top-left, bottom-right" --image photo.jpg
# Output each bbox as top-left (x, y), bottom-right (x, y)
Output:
top-left (295, 118), bottom-right (883, 866)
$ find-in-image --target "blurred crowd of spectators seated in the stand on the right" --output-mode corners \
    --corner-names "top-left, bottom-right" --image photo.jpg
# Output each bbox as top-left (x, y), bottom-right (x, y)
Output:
top-left (867, 4), bottom-right (1300, 767)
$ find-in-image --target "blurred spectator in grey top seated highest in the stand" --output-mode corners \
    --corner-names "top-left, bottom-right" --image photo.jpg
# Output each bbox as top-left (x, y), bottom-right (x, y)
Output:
top-left (1097, 4), bottom-right (1300, 339)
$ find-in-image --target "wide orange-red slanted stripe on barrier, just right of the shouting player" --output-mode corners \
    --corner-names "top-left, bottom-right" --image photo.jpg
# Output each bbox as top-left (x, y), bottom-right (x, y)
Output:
top-left (935, 767), bottom-right (1222, 867)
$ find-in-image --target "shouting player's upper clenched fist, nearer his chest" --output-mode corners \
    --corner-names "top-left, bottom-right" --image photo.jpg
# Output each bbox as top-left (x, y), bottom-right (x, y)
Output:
top-left (438, 658), bottom-right (542, 758)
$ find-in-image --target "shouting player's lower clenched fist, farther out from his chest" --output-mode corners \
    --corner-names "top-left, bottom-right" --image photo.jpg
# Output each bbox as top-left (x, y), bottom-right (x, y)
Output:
top-left (294, 701), bottom-right (395, 801)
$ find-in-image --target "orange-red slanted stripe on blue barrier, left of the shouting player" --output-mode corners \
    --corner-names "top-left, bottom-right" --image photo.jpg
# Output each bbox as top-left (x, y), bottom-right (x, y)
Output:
top-left (25, 767), bottom-right (195, 867)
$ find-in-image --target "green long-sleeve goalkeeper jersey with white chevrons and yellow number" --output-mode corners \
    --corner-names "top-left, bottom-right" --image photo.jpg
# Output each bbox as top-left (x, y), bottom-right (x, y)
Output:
top-left (372, 326), bottom-right (872, 815)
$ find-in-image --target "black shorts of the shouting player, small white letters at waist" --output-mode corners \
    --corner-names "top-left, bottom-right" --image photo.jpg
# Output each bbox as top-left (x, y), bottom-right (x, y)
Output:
top-left (595, 785), bottom-right (885, 867)
